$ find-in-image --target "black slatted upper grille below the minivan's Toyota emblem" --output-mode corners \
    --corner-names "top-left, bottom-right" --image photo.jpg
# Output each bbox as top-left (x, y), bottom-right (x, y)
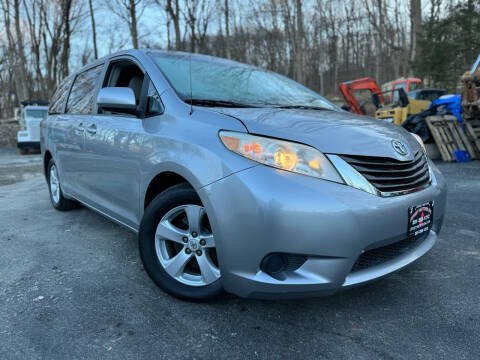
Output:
top-left (342, 150), bottom-right (430, 192)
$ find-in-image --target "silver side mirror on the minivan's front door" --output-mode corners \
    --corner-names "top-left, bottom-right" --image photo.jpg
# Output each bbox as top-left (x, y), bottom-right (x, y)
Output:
top-left (97, 87), bottom-right (137, 114)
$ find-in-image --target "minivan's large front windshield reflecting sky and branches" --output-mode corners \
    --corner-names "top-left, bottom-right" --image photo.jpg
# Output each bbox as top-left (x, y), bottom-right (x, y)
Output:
top-left (152, 53), bottom-right (338, 110)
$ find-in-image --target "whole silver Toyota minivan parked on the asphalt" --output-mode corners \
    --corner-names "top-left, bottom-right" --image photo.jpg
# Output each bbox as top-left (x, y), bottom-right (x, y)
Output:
top-left (41, 50), bottom-right (446, 300)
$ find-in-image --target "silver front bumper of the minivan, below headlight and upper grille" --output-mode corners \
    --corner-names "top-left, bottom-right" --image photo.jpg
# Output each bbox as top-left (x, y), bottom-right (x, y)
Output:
top-left (199, 165), bottom-right (446, 299)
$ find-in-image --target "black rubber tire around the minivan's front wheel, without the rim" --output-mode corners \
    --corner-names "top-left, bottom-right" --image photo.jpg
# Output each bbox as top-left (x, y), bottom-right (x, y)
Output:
top-left (138, 184), bottom-right (223, 301)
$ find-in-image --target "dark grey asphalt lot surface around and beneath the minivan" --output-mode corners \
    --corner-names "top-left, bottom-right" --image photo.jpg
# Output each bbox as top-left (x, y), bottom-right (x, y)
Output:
top-left (0, 150), bottom-right (480, 359)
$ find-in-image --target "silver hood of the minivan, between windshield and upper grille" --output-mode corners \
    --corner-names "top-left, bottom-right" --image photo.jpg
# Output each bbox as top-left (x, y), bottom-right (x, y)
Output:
top-left (215, 108), bottom-right (420, 161)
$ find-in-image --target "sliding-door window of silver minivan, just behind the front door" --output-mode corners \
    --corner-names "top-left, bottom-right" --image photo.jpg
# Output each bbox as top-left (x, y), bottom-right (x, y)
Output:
top-left (65, 65), bottom-right (103, 114)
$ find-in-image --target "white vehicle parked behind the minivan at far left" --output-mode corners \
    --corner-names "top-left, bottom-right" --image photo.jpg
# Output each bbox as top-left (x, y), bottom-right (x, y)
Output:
top-left (17, 100), bottom-right (48, 154)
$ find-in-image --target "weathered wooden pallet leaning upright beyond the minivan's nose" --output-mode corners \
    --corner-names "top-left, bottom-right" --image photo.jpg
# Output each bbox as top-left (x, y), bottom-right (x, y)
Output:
top-left (425, 115), bottom-right (478, 161)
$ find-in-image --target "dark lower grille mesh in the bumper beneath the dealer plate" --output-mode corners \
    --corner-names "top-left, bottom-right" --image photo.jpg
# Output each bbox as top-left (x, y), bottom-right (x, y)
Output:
top-left (351, 232), bottom-right (428, 272)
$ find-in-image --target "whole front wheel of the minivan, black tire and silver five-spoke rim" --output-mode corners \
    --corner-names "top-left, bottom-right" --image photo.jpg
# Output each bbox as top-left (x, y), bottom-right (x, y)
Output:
top-left (138, 184), bottom-right (223, 301)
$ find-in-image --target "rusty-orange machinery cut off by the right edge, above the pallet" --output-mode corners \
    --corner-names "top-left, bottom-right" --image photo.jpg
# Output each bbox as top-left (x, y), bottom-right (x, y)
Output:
top-left (461, 55), bottom-right (480, 119)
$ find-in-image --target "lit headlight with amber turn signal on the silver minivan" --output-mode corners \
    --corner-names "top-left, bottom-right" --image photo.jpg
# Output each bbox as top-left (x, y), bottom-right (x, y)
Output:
top-left (219, 131), bottom-right (343, 183)
